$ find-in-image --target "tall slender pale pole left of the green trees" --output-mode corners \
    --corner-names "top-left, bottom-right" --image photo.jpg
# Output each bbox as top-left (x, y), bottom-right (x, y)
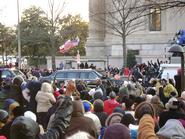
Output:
top-left (17, 0), bottom-right (21, 68)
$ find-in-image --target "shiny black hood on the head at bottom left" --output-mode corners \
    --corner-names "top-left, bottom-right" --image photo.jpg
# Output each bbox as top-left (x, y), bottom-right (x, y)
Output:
top-left (10, 116), bottom-right (40, 139)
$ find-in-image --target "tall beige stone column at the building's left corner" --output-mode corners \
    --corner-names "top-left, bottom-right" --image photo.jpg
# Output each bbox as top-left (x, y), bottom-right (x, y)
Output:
top-left (86, 0), bottom-right (106, 60)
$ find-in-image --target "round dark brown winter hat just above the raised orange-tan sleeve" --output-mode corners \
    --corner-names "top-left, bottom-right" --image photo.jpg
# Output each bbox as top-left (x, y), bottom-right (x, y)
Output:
top-left (135, 102), bottom-right (155, 120)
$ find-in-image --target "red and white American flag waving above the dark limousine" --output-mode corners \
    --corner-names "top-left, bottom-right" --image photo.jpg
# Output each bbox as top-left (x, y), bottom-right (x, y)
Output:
top-left (59, 37), bottom-right (80, 53)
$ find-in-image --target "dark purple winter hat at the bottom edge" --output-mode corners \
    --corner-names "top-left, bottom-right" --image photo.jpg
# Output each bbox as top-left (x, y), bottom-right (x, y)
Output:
top-left (104, 123), bottom-right (131, 139)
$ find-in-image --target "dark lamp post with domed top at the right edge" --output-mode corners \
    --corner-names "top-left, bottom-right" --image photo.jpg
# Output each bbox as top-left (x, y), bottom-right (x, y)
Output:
top-left (168, 44), bottom-right (184, 92)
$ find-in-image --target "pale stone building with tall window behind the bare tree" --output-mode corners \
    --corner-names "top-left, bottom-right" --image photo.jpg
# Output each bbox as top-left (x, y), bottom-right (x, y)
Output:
top-left (86, 0), bottom-right (185, 68)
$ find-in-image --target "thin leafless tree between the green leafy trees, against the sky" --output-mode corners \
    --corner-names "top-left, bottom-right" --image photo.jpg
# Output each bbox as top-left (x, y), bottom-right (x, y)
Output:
top-left (47, 0), bottom-right (66, 69)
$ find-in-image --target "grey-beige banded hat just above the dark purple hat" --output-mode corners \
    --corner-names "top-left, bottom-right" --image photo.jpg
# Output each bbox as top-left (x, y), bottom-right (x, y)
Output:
top-left (105, 112), bottom-right (123, 126)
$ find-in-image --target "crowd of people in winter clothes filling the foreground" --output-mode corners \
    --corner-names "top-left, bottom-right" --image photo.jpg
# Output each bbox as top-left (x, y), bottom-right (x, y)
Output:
top-left (0, 64), bottom-right (185, 139)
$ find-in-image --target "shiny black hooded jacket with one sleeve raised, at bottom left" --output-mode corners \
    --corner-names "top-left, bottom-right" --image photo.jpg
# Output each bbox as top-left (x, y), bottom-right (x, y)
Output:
top-left (10, 96), bottom-right (73, 139)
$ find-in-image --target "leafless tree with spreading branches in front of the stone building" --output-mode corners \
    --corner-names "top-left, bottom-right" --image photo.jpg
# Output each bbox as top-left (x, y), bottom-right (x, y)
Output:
top-left (90, 0), bottom-right (148, 66)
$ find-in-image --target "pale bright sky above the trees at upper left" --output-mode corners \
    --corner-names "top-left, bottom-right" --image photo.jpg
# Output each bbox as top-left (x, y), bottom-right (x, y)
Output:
top-left (0, 0), bottom-right (89, 26)
